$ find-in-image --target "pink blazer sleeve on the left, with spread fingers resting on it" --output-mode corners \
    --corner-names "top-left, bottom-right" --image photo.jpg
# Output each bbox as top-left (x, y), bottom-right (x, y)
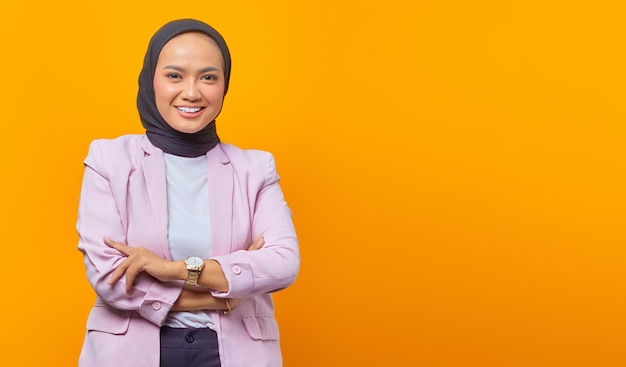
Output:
top-left (76, 141), bottom-right (182, 325)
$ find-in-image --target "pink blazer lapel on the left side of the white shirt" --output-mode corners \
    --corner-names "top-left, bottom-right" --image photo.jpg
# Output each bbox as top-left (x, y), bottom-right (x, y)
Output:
top-left (141, 139), bottom-right (172, 260)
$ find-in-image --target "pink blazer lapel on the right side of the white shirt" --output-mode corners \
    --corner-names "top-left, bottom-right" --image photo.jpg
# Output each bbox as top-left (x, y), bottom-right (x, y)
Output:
top-left (207, 145), bottom-right (234, 256)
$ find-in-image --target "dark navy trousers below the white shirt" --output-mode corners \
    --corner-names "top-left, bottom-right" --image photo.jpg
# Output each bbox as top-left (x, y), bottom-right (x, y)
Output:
top-left (160, 326), bottom-right (220, 367)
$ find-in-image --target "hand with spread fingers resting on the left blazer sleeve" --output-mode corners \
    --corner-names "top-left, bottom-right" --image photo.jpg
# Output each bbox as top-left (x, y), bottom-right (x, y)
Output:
top-left (104, 238), bottom-right (183, 294)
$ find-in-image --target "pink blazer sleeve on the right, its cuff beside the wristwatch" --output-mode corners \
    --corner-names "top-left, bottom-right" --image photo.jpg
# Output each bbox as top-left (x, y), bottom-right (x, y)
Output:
top-left (212, 151), bottom-right (300, 298)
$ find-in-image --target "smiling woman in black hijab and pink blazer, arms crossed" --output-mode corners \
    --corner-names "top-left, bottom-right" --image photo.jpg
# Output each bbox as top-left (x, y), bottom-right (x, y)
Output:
top-left (77, 19), bottom-right (300, 367)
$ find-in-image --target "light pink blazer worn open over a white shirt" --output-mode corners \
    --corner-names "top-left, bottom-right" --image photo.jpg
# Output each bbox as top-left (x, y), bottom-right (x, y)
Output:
top-left (77, 135), bottom-right (300, 367)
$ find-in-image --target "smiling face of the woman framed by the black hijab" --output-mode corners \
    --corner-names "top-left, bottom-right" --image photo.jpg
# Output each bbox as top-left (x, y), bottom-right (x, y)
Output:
top-left (154, 32), bottom-right (224, 133)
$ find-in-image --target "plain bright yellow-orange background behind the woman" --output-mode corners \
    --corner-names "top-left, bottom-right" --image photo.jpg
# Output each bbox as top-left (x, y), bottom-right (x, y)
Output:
top-left (0, 0), bottom-right (626, 367)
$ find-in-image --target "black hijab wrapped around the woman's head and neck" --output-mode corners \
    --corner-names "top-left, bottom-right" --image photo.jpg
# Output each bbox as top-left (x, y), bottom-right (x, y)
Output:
top-left (137, 19), bottom-right (230, 157)
